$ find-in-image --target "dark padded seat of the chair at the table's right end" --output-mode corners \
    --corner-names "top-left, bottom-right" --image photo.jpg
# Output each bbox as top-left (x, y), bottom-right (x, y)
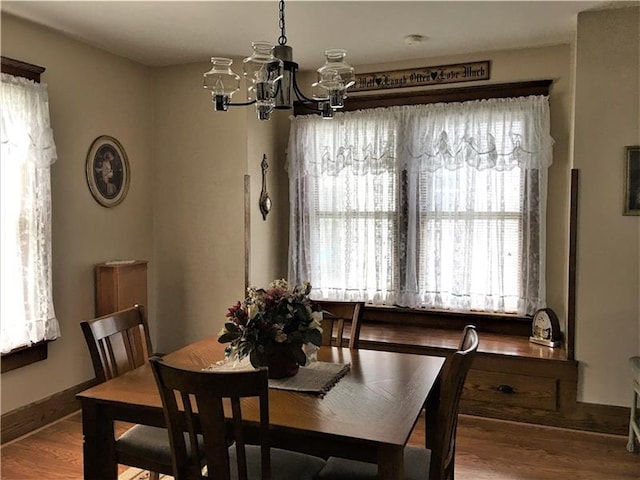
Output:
top-left (317, 447), bottom-right (431, 480)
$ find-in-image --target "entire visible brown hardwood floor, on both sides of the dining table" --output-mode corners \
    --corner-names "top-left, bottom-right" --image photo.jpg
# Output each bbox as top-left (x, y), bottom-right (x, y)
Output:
top-left (0, 413), bottom-right (640, 480)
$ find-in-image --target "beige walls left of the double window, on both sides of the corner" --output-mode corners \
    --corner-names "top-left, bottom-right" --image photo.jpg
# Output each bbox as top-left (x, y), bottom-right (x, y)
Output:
top-left (1, 14), bottom-right (288, 413)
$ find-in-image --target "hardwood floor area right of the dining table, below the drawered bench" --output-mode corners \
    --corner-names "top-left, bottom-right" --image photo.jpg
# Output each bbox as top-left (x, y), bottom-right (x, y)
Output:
top-left (411, 415), bottom-right (640, 480)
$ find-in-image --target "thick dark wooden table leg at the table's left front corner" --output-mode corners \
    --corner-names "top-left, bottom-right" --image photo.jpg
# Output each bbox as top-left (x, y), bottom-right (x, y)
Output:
top-left (82, 400), bottom-right (118, 480)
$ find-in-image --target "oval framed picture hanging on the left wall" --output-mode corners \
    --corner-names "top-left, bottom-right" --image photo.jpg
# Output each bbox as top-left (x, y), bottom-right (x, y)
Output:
top-left (86, 135), bottom-right (129, 207)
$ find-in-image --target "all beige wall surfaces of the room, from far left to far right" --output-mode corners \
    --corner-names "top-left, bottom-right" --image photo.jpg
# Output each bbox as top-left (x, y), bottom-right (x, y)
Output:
top-left (1, 9), bottom-right (640, 412)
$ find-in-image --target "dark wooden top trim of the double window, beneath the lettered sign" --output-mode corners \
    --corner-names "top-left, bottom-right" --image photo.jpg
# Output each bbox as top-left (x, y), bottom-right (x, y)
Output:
top-left (293, 80), bottom-right (552, 115)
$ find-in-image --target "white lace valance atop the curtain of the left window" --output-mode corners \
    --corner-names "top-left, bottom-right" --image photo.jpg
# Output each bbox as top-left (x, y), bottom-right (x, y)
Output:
top-left (0, 73), bottom-right (57, 167)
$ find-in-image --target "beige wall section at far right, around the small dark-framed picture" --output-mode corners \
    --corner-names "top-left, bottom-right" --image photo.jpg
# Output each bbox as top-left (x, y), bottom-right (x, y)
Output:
top-left (574, 7), bottom-right (640, 405)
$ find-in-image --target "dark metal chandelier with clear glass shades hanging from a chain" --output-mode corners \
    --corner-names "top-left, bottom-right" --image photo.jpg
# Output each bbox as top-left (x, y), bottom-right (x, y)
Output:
top-left (204, 0), bottom-right (355, 120)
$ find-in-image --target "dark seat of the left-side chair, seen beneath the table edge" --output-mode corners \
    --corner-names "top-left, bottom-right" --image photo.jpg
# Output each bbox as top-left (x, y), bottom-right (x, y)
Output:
top-left (116, 425), bottom-right (204, 475)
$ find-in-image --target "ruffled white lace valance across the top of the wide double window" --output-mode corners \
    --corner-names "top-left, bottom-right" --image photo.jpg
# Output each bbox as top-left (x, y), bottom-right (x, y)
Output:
top-left (288, 96), bottom-right (553, 176)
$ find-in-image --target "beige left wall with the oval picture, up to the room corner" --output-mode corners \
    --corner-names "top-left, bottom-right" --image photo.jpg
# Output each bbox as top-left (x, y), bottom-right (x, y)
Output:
top-left (1, 14), bottom-right (154, 413)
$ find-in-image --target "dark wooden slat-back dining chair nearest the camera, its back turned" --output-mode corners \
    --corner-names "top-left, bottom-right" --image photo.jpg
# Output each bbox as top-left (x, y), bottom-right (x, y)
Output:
top-left (150, 357), bottom-right (325, 480)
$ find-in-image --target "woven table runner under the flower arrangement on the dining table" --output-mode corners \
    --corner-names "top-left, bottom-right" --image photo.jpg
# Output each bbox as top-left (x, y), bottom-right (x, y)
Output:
top-left (204, 358), bottom-right (351, 395)
